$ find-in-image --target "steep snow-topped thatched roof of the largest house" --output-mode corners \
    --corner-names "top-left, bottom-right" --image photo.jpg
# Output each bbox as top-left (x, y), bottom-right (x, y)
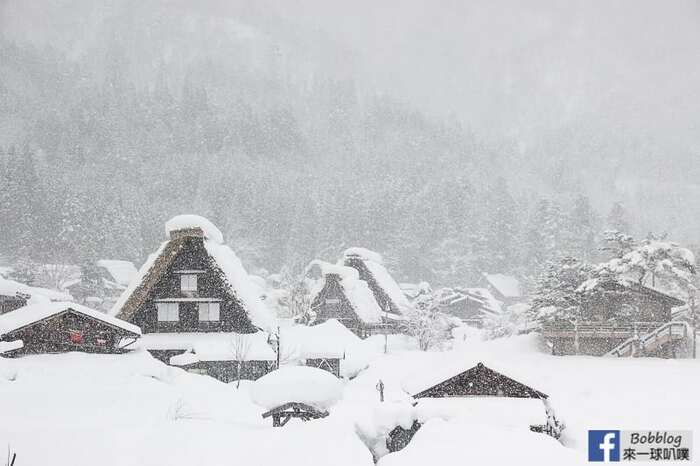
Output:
top-left (110, 215), bottom-right (273, 330)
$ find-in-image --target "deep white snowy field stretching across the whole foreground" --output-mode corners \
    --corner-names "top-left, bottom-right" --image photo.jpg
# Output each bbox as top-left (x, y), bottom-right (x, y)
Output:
top-left (0, 337), bottom-right (700, 466)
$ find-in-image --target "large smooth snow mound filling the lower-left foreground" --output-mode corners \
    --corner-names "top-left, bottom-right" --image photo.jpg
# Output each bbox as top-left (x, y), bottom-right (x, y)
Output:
top-left (0, 352), bottom-right (373, 466)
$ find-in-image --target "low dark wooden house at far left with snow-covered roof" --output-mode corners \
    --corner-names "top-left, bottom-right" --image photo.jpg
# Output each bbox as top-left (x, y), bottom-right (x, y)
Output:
top-left (0, 302), bottom-right (141, 357)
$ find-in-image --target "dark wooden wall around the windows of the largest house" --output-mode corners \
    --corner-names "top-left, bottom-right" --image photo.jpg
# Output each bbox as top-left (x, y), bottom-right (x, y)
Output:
top-left (131, 237), bottom-right (256, 333)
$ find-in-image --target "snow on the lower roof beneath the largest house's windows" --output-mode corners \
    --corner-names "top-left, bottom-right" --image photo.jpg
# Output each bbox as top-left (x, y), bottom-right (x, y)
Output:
top-left (139, 332), bottom-right (277, 365)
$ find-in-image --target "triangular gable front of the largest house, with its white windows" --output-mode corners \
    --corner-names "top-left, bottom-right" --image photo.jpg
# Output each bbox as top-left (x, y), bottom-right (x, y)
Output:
top-left (119, 229), bottom-right (257, 333)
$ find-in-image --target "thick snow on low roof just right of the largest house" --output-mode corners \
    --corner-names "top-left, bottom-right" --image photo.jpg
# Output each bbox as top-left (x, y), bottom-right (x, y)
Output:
top-left (280, 319), bottom-right (362, 360)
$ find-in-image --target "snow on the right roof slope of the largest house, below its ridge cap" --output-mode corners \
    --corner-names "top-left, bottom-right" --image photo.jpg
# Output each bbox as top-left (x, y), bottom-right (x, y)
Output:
top-left (204, 240), bottom-right (274, 331)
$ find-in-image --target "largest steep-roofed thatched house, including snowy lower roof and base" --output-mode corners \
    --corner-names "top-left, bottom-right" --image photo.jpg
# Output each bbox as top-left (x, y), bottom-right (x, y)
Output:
top-left (111, 215), bottom-right (276, 381)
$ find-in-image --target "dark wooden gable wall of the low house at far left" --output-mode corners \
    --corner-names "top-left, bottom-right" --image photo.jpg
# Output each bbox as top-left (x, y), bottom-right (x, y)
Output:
top-left (0, 307), bottom-right (140, 357)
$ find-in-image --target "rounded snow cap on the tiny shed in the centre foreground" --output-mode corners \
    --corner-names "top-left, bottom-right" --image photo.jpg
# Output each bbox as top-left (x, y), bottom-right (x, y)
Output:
top-left (251, 366), bottom-right (343, 410)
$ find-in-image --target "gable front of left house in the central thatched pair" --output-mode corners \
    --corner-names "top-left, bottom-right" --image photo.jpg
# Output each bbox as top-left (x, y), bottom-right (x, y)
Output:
top-left (311, 273), bottom-right (369, 337)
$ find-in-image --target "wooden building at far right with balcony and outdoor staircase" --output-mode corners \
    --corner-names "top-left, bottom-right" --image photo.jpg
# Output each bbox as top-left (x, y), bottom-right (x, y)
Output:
top-left (542, 279), bottom-right (690, 357)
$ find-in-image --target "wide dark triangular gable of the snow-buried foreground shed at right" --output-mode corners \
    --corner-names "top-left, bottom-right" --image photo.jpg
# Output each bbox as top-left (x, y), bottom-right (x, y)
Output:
top-left (414, 363), bottom-right (547, 399)
